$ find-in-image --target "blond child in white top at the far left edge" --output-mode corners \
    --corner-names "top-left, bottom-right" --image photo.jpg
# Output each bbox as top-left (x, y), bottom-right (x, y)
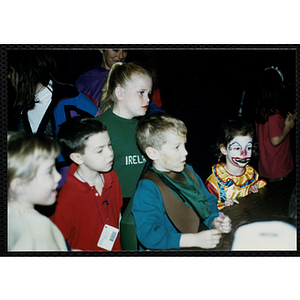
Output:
top-left (7, 132), bottom-right (67, 251)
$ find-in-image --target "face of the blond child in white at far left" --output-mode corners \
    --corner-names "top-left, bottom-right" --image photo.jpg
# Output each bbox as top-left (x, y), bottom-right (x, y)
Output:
top-left (24, 158), bottom-right (61, 206)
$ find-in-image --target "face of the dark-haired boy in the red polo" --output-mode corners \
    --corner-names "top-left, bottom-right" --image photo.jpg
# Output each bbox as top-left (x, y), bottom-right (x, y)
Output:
top-left (81, 131), bottom-right (114, 172)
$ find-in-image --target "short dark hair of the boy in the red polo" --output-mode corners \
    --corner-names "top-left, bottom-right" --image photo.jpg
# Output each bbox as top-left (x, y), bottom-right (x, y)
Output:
top-left (57, 117), bottom-right (106, 161)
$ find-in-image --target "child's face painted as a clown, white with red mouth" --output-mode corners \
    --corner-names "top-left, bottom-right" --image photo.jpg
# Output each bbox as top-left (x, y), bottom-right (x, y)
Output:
top-left (223, 135), bottom-right (252, 168)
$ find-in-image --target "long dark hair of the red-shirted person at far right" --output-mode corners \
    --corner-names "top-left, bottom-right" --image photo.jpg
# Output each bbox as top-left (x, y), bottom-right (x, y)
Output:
top-left (255, 67), bottom-right (287, 124)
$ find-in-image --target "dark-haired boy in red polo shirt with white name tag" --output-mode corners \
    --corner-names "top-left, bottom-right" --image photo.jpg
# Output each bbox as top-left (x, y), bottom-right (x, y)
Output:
top-left (51, 117), bottom-right (123, 251)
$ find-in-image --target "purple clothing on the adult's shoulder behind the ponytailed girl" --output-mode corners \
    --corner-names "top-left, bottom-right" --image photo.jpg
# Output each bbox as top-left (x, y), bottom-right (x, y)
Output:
top-left (75, 65), bottom-right (109, 104)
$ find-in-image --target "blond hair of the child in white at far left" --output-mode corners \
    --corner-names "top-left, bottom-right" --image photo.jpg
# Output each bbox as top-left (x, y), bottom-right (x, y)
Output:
top-left (7, 132), bottom-right (59, 198)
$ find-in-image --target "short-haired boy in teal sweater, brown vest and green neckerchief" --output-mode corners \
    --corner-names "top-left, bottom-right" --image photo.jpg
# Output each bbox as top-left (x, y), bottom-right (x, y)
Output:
top-left (132, 113), bottom-right (231, 250)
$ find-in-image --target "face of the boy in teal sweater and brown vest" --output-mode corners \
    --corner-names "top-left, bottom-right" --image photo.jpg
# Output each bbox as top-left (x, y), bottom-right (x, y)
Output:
top-left (154, 131), bottom-right (188, 172)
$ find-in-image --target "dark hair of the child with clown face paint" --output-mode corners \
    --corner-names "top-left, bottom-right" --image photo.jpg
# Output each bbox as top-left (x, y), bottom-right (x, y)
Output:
top-left (215, 119), bottom-right (256, 161)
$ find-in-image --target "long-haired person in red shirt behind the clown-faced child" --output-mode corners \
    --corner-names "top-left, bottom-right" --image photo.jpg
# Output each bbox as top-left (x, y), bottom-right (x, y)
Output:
top-left (255, 67), bottom-right (296, 182)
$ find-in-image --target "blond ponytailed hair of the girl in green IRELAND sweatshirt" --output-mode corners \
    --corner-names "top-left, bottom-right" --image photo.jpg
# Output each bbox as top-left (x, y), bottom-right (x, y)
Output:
top-left (101, 62), bottom-right (152, 112)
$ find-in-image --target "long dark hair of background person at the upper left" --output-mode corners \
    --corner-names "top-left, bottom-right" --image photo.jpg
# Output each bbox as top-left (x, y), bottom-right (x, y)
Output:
top-left (8, 50), bottom-right (56, 113)
